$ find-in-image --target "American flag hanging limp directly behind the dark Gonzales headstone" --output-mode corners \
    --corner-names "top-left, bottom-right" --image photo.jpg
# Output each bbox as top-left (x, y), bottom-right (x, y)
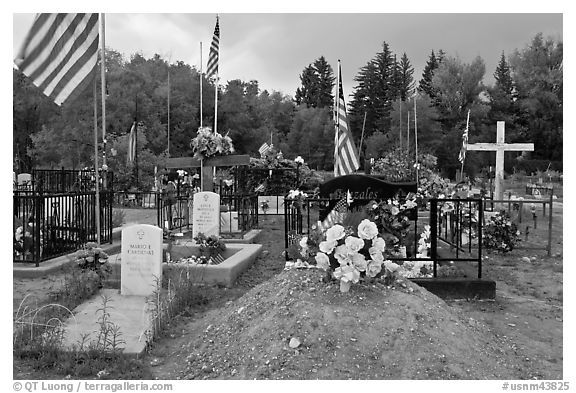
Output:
top-left (334, 61), bottom-right (360, 176)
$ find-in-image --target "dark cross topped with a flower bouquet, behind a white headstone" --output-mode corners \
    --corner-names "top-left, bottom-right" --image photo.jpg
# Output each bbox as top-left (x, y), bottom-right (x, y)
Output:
top-left (166, 154), bottom-right (250, 191)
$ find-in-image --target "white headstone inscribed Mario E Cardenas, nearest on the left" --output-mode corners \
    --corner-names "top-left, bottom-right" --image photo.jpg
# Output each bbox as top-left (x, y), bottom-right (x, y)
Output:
top-left (120, 224), bottom-right (162, 296)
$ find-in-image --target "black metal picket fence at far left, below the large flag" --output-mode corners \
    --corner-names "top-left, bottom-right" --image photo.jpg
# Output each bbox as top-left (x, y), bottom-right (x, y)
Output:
top-left (13, 191), bottom-right (113, 266)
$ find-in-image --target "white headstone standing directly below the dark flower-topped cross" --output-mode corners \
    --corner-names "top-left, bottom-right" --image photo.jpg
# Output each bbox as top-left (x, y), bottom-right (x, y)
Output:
top-left (192, 191), bottom-right (220, 238)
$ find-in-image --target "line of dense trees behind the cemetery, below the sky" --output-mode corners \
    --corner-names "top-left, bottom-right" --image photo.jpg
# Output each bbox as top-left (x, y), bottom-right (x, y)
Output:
top-left (13, 34), bottom-right (563, 187)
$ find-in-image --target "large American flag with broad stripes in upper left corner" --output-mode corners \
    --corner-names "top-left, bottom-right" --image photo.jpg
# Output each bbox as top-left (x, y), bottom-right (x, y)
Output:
top-left (14, 14), bottom-right (99, 105)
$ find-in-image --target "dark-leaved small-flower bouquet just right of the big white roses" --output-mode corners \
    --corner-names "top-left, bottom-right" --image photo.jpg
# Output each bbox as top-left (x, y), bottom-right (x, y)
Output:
top-left (367, 193), bottom-right (417, 254)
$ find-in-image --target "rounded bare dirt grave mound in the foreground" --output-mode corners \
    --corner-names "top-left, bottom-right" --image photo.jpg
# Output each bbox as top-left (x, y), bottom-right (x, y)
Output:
top-left (155, 270), bottom-right (519, 379)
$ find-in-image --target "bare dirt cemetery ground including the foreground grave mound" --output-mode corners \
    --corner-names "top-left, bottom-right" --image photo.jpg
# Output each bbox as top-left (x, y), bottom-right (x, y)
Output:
top-left (13, 204), bottom-right (563, 380)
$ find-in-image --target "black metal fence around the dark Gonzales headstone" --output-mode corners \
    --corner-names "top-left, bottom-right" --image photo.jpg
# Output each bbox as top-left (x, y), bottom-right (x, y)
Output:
top-left (284, 198), bottom-right (483, 278)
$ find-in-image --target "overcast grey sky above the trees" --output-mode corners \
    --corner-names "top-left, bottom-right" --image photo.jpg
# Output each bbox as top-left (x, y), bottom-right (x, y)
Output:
top-left (13, 11), bottom-right (563, 100)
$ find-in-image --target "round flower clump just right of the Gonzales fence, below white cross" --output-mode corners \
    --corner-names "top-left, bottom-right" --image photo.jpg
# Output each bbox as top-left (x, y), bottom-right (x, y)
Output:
top-left (482, 210), bottom-right (522, 253)
